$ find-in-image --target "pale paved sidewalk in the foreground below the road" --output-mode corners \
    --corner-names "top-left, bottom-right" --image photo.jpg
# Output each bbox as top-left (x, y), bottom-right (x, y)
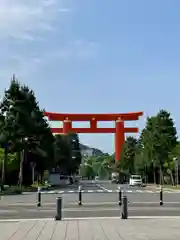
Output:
top-left (0, 218), bottom-right (180, 240)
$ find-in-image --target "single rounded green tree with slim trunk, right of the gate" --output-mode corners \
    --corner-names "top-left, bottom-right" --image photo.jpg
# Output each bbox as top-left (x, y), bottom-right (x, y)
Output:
top-left (140, 110), bottom-right (177, 183)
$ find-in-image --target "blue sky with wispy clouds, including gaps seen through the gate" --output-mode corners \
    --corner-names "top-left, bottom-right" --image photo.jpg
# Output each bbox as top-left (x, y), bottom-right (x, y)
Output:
top-left (0, 0), bottom-right (180, 152)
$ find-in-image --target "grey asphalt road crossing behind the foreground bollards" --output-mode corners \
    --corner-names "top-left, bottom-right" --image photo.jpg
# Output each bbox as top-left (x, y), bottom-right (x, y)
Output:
top-left (0, 181), bottom-right (180, 219)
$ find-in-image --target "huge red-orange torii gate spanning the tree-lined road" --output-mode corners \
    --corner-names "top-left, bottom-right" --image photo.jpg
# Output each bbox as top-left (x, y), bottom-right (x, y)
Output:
top-left (44, 112), bottom-right (143, 161)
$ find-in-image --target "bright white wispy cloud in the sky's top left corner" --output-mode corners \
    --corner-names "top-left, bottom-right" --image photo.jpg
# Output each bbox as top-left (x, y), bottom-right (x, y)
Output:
top-left (0, 0), bottom-right (68, 40)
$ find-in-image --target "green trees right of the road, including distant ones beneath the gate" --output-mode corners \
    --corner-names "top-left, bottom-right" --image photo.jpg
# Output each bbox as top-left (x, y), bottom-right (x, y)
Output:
top-left (81, 109), bottom-right (180, 184)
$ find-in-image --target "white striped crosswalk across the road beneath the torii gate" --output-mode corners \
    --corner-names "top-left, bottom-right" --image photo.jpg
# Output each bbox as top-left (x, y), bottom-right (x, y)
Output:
top-left (41, 189), bottom-right (180, 194)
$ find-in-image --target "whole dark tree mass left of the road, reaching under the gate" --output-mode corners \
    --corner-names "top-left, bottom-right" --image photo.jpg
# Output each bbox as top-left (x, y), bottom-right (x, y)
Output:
top-left (0, 77), bottom-right (81, 185)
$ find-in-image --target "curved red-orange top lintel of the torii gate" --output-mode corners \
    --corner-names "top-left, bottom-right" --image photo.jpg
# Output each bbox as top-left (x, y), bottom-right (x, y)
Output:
top-left (44, 112), bottom-right (143, 121)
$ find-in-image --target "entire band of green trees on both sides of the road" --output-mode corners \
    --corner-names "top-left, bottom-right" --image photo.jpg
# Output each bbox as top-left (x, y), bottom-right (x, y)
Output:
top-left (0, 76), bottom-right (180, 185)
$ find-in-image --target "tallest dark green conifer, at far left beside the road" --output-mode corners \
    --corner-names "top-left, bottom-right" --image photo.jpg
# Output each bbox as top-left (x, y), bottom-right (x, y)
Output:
top-left (0, 78), bottom-right (54, 185)
